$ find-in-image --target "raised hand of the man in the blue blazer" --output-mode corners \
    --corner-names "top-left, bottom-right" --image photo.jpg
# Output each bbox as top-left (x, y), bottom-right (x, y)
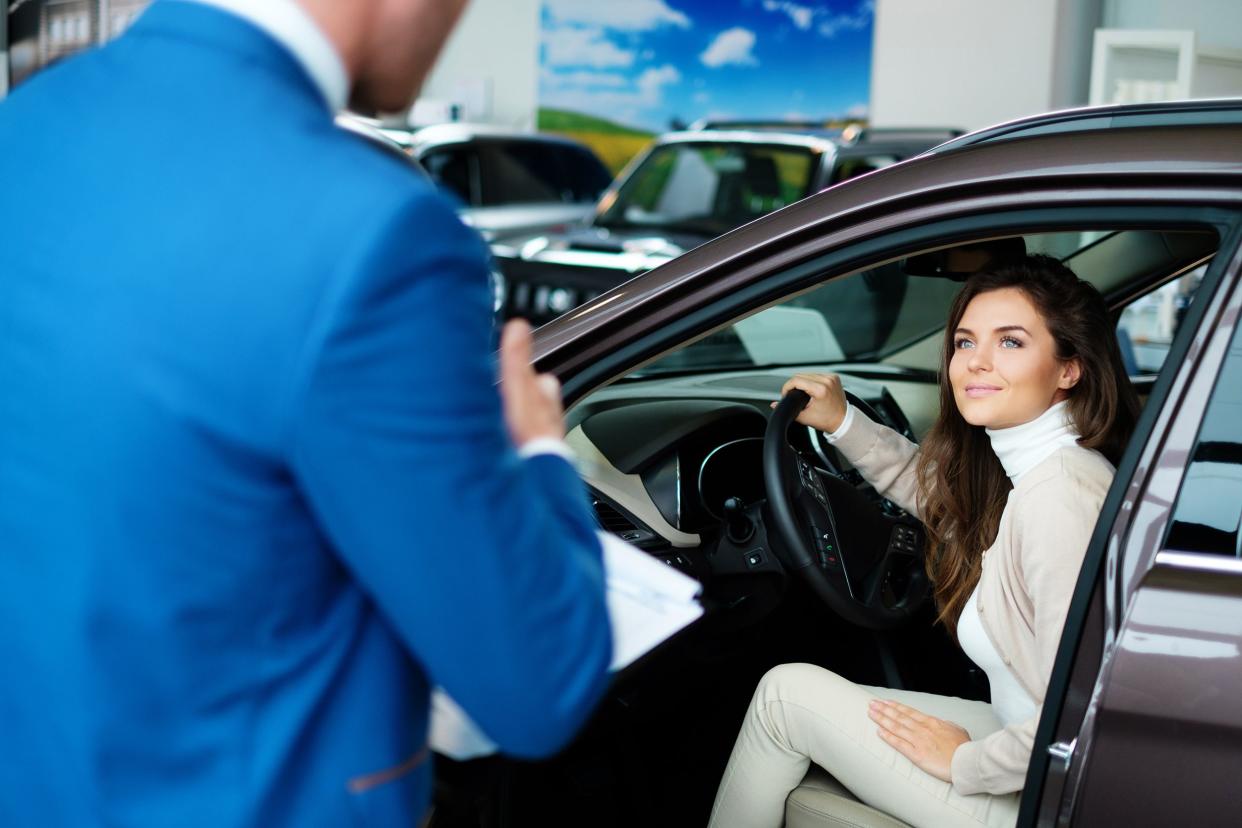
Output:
top-left (501, 319), bottom-right (565, 447)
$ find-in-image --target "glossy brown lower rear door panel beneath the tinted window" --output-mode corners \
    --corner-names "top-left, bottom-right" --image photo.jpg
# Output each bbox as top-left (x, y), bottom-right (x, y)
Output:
top-left (1068, 555), bottom-right (1242, 826)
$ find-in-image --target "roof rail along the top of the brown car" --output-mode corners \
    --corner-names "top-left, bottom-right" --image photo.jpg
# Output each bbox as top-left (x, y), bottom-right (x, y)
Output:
top-left (928, 98), bottom-right (1242, 154)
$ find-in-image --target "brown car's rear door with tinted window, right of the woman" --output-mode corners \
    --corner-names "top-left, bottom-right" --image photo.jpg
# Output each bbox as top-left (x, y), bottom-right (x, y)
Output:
top-left (1022, 230), bottom-right (1242, 826)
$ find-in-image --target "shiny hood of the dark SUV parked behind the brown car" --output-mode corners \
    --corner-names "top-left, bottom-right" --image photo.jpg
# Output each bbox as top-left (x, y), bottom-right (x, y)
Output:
top-left (492, 225), bottom-right (708, 273)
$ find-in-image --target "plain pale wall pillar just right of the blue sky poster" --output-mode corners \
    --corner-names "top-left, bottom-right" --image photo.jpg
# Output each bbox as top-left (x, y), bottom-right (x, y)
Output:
top-left (871, 0), bottom-right (1102, 129)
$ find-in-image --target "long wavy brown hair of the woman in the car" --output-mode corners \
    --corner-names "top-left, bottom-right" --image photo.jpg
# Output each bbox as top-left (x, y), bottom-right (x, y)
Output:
top-left (918, 256), bottom-right (1139, 634)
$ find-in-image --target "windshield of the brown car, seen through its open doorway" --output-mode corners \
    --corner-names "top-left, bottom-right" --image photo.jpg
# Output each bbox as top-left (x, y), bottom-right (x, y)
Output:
top-left (633, 231), bottom-right (1108, 376)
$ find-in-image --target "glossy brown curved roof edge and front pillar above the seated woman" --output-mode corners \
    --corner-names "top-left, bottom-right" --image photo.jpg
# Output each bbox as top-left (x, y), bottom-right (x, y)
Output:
top-left (537, 116), bottom-right (1242, 359)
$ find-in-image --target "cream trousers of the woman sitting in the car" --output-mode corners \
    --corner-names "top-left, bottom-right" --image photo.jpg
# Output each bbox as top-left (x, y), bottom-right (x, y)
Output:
top-left (710, 664), bottom-right (1020, 828)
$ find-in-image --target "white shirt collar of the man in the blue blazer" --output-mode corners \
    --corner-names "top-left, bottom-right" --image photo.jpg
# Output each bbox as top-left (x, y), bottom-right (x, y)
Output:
top-left (172, 0), bottom-right (349, 113)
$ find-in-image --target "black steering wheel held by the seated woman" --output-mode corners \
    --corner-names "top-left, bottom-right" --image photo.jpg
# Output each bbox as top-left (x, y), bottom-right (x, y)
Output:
top-left (764, 389), bottom-right (930, 629)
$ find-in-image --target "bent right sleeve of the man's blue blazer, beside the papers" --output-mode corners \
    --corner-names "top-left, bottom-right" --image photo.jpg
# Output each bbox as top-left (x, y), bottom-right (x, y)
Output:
top-left (289, 192), bottom-right (611, 756)
